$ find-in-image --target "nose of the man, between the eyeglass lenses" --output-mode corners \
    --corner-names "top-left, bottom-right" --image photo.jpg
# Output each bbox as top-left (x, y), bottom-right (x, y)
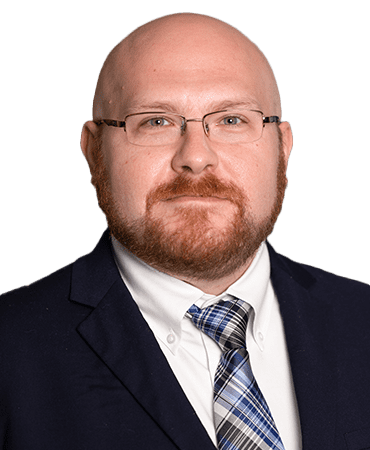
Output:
top-left (172, 122), bottom-right (218, 175)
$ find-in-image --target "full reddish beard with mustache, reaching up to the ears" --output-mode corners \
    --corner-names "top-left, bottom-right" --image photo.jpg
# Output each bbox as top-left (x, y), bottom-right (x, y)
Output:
top-left (91, 129), bottom-right (287, 281)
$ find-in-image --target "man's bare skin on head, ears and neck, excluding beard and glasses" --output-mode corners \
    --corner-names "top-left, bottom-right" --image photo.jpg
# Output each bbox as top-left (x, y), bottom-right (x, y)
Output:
top-left (81, 14), bottom-right (293, 294)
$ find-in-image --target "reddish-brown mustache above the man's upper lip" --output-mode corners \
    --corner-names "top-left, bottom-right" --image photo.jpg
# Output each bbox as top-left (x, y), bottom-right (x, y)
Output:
top-left (146, 173), bottom-right (245, 211)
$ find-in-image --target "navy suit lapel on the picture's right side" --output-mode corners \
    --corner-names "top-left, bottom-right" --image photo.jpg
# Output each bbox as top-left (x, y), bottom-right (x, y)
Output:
top-left (269, 246), bottom-right (337, 450)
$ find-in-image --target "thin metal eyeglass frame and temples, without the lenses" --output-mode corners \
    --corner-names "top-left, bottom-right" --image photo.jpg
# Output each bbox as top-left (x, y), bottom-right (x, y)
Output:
top-left (95, 109), bottom-right (281, 145)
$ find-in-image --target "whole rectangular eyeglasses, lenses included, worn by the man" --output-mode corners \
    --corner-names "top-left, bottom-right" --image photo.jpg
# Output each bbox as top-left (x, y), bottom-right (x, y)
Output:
top-left (97, 110), bottom-right (280, 147)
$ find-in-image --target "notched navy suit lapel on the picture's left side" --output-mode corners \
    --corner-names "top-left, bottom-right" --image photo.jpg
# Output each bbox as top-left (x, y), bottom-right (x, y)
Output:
top-left (71, 232), bottom-right (214, 450)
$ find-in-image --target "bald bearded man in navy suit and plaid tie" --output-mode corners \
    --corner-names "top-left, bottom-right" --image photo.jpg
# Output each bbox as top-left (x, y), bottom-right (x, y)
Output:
top-left (0, 14), bottom-right (370, 450)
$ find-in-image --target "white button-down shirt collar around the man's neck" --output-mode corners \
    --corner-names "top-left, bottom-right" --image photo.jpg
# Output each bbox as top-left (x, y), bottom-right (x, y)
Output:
top-left (112, 237), bottom-right (271, 354)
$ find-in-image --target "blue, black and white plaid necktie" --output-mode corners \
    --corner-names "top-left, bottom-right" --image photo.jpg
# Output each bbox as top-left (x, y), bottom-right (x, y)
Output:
top-left (188, 298), bottom-right (284, 450)
